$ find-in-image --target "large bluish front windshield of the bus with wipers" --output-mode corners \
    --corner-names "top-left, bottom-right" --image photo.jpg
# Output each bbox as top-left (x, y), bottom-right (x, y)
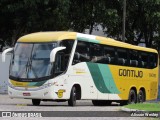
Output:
top-left (10, 42), bottom-right (57, 79)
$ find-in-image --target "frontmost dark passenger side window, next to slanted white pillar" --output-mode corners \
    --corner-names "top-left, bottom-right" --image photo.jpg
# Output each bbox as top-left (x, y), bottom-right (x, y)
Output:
top-left (72, 41), bottom-right (90, 65)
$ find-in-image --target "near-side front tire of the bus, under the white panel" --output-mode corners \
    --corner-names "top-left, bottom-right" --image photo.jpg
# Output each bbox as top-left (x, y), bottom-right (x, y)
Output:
top-left (68, 86), bottom-right (77, 106)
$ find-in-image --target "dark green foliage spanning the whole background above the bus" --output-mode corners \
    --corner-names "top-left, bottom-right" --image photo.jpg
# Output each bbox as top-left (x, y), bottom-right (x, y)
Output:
top-left (0, 0), bottom-right (160, 48)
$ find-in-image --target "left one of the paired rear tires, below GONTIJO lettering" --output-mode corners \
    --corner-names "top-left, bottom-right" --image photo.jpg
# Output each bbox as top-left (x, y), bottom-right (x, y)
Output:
top-left (128, 89), bottom-right (137, 104)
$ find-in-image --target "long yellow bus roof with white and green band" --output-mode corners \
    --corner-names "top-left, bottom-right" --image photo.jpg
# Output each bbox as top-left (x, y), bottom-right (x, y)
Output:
top-left (17, 31), bottom-right (157, 53)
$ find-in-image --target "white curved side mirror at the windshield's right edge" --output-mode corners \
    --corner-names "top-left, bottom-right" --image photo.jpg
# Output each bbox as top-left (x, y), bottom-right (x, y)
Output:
top-left (50, 47), bottom-right (66, 63)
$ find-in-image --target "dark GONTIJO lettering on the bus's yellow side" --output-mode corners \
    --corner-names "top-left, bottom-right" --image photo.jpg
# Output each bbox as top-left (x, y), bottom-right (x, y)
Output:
top-left (119, 69), bottom-right (143, 78)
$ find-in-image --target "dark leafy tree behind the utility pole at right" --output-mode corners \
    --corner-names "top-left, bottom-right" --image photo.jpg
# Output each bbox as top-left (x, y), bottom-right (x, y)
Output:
top-left (102, 0), bottom-right (160, 47)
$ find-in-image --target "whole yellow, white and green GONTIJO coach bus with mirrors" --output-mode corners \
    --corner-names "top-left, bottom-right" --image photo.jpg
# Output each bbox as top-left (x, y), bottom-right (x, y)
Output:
top-left (2, 31), bottom-right (159, 106)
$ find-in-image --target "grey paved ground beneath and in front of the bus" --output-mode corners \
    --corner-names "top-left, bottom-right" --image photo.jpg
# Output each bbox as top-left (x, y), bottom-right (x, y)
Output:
top-left (0, 94), bottom-right (154, 120)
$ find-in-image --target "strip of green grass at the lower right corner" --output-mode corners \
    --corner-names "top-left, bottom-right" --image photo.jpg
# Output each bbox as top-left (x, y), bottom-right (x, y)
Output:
top-left (124, 103), bottom-right (160, 111)
